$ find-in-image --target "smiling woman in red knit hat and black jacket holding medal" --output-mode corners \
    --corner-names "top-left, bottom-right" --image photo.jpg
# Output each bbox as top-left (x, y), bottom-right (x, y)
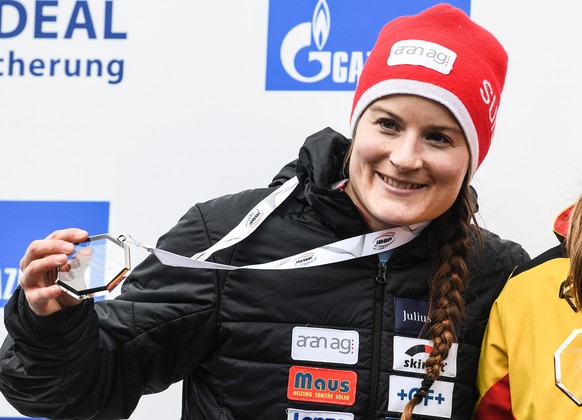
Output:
top-left (0, 5), bottom-right (528, 420)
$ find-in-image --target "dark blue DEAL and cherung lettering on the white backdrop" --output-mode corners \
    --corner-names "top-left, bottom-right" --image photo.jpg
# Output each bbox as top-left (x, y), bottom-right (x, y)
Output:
top-left (0, 0), bottom-right (127, 84)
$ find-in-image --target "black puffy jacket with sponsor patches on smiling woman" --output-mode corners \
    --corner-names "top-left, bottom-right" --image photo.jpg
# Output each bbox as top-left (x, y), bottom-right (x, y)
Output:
top-left (0, 129), bottom-right (528, 420)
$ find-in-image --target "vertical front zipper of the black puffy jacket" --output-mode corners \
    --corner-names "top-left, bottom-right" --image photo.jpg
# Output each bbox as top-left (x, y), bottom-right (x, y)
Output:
top-left (368, 261), bottom-right (388, 420)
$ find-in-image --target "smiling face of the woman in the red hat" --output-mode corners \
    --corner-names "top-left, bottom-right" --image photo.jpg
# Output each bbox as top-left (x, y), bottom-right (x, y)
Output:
top-left (346, 95), bottom-right (470, 230)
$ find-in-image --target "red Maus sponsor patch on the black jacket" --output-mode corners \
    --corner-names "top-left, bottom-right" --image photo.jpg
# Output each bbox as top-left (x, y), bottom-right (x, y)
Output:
top-left (287, 366), bottom-right (358, 405)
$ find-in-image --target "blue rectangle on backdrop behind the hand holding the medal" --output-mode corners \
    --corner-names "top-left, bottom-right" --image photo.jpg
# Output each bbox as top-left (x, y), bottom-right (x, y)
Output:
top-left (0, 201), bottom-right (109, 307)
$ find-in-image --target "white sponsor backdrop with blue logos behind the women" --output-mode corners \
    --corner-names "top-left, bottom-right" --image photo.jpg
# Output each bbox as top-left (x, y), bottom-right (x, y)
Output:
top-left (0, 0), bottom-right (582, 419)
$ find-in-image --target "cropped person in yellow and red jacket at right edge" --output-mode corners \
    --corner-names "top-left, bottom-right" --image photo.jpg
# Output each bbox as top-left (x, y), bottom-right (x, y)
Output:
top-left (476, 196), bottom-right (582, 420)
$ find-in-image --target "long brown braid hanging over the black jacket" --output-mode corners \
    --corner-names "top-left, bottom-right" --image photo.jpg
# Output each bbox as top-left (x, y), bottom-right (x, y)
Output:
top-left (401, 176), bottom-right (480, 420)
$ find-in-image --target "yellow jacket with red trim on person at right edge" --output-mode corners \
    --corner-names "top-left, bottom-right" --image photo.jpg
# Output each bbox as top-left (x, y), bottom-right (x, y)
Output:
top-left (475, 246), bottom-right (582, 420)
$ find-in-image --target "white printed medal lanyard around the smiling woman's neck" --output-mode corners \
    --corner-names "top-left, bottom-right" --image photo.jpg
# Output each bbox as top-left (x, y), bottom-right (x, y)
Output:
top-left (140, 177), bottom-right (430, 270)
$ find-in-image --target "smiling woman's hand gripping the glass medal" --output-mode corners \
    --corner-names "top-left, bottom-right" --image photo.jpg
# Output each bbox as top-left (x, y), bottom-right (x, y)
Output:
top-left (20, 228), bottom-right (88, 316)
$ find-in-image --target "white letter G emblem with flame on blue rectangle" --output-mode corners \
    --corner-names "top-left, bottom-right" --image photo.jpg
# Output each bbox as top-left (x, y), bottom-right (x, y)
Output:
top-left (281, 0), bottom-right (332, 83)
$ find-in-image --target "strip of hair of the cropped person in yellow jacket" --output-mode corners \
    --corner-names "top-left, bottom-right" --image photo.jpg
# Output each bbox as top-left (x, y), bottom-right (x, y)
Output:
top-left (566, 195), bottom-right (582, 309)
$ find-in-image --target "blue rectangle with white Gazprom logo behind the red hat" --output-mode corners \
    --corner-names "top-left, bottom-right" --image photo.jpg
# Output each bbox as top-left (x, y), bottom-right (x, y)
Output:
top-left (266, 0), bottom-right (471, 90)
